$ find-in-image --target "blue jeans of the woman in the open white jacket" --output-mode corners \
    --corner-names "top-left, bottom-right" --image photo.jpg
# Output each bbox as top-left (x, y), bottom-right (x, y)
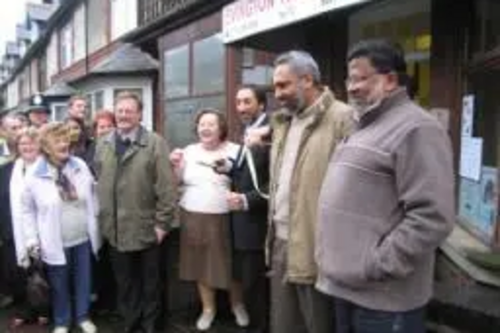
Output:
top-left (47, 242), bottom-right (92, 327)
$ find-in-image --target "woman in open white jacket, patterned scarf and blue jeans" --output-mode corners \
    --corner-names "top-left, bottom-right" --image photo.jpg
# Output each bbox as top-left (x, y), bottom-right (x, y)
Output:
top-left (22, 123), bottom-right (100, 333)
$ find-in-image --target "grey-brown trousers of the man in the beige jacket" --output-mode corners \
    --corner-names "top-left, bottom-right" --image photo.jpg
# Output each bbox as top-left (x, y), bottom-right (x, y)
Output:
top-left (271, 239), bottom-right (335, 333)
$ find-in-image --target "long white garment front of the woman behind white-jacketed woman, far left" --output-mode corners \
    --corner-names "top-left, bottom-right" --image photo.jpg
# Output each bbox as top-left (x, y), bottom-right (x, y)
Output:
top-left (9, 158), bottom-right (36, 266)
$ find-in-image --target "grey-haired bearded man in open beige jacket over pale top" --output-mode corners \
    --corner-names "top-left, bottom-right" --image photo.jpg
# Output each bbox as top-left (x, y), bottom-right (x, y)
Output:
top-left (268, 51), bottom-right (353, 333)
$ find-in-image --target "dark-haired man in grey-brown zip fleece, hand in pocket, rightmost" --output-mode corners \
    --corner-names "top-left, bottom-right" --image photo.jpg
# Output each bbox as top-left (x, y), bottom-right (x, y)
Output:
top-left (316, 40), bottom-right (455, 333)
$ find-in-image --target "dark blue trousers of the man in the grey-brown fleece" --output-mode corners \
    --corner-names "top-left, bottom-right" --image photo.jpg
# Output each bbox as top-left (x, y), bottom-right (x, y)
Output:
top-left (335, 299), bottom-right (425, 333)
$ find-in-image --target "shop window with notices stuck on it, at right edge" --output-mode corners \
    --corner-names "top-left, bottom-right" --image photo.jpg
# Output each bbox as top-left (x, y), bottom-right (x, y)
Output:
top-left (459, 0), bottom-right (500, 250)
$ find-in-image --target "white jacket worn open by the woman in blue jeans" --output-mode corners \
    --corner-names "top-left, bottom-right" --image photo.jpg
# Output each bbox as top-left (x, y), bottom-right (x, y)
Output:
top-left (21, 157), bottom-right (101, 265)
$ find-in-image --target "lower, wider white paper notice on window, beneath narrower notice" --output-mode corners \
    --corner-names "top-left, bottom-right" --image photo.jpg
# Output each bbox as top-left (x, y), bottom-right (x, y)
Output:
top-left (460, 136), bottom-right (483, 181)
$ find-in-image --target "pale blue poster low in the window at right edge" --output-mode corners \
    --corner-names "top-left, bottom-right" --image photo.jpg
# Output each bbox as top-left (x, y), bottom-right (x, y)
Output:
top-left (477, 166), bottom-right (498, 235)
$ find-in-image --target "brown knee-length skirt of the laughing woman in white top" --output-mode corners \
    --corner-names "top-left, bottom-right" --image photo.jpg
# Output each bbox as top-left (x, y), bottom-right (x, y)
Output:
top-left (179, 209), bottom-right (231, 289)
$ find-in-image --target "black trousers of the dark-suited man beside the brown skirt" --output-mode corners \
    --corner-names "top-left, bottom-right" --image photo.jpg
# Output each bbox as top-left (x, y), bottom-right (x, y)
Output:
top-left (232, 250), bottom-right (270, 333)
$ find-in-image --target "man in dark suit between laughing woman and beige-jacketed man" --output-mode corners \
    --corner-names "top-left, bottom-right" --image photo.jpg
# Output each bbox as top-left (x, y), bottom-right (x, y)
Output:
top-left (228, 86), bottom-right (269, 333)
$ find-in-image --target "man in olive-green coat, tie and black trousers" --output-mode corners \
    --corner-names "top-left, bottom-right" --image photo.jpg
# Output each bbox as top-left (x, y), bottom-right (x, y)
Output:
top-left (94, 93), bottom-right (175, 333)
